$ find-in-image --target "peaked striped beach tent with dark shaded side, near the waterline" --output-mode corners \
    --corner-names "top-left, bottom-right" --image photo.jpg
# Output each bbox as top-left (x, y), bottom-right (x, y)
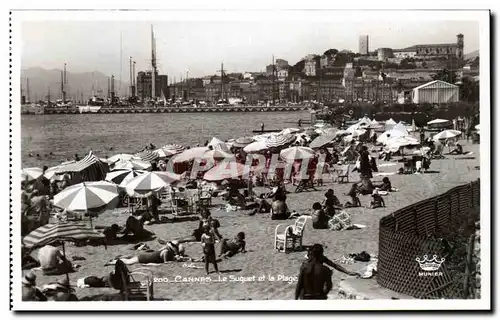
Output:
top-left (55, 151), bottom-right (109, 182)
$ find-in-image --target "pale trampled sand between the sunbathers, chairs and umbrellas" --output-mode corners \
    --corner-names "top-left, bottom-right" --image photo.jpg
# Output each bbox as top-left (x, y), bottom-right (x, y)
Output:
top-left (26, 141), bottom-right (480, 300)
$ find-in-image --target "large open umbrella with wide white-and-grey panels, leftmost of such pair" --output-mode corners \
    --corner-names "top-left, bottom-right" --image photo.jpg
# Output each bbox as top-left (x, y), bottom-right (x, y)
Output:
top-left (54, 181), bottom-right (119, 212)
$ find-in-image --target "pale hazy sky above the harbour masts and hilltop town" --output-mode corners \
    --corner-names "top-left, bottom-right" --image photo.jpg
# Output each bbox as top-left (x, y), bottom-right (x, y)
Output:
top-left (21, 19), bottom-right (479, 82)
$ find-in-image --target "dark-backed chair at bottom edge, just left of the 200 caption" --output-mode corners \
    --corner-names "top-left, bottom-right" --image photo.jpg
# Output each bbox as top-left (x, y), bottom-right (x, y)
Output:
top-left (110, 259), bottom-right (154, 301)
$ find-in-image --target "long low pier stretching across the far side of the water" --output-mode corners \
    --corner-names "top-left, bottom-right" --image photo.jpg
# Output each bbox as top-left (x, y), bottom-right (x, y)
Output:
top-left (21, 105), bottom-right (308, 115)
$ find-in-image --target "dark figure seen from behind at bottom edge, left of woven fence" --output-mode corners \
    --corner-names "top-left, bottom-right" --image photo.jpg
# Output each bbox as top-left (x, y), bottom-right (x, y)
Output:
top-left (295, 244), bottom-right (333, 300)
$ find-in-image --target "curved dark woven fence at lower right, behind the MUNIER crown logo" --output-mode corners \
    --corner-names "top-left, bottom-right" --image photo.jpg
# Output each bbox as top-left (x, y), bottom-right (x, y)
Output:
top-left (377, 180), bottom-right (480, 299)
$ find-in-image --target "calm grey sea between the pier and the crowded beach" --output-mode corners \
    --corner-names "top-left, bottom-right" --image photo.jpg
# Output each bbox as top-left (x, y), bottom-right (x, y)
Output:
top-left (21, 111), bottom-right (310, 167)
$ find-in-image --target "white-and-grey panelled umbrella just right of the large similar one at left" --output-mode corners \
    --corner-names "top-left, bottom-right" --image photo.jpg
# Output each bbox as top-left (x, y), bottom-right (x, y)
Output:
top-left (125, 171), bottom-right (184, 196)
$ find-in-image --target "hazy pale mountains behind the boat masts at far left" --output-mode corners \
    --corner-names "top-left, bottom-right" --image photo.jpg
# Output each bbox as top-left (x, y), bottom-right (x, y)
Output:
top-left (21, 67), bottom-right (129, 101)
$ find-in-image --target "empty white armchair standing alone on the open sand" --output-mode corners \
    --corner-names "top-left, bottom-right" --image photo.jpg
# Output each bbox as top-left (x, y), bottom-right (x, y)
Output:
top-left (274, 216), bottom-right (307, 252)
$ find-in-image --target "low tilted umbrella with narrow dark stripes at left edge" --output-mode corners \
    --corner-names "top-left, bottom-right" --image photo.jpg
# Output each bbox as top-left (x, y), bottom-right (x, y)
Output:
top-left (22, 222), bottom-right (104, 249)
